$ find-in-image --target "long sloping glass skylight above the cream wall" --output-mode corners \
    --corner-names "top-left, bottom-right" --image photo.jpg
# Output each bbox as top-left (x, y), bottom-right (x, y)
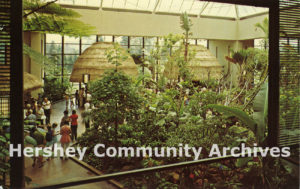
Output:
top-left (55, 0), bottom-right (268, 18)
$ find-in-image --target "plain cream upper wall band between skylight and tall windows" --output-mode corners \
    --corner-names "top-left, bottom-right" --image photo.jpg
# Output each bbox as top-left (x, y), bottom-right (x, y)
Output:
top-left (72, 8), bottom-right (264, 40)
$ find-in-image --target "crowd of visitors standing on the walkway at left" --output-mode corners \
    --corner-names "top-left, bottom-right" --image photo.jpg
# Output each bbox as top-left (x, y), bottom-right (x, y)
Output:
top-left (24, 88), bottom-right (92, 167)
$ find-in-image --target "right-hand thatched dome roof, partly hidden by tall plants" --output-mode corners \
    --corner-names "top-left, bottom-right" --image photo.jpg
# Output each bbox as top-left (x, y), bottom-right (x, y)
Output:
top-left (164, 45), bottom-right (223, 81)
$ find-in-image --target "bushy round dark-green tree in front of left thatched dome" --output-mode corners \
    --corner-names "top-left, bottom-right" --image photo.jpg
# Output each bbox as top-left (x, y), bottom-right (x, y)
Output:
top-left (90, 71), bottom-right (141, 145)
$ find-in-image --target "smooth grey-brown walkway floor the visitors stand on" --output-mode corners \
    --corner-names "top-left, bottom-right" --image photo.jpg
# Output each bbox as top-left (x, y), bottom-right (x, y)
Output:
top-left (25, 101), bottom-right (116, 189)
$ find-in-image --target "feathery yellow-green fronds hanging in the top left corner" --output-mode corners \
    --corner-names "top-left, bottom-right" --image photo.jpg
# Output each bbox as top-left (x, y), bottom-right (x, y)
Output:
top-left (23, 0), bottom-right (95, 37)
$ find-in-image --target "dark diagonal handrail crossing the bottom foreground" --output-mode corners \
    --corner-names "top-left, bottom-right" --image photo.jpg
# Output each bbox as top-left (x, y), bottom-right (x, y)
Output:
top-left (34, 153), bottom-right (255, 189)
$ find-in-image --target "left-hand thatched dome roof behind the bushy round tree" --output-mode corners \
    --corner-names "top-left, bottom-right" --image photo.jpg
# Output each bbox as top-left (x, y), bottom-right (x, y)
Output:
top-left (70, 42), bottom-right (138, 82)
